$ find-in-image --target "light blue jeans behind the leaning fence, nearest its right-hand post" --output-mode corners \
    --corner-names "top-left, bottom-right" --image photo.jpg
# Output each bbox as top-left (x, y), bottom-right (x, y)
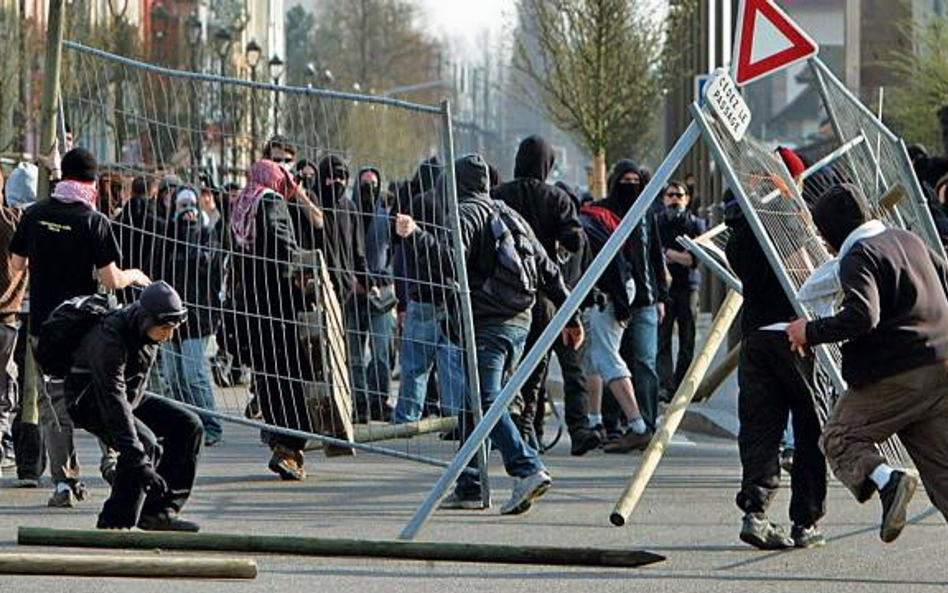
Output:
top-left (392, 301), bottom-right (467, 423)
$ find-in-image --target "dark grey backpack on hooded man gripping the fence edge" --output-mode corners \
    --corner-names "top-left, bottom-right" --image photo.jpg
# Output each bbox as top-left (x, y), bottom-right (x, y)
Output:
top-left (483, 200), bottom-right (540, 315)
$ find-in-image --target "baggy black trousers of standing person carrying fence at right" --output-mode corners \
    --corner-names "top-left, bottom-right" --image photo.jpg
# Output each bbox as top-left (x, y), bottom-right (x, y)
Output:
top-left (736, 331), bottom-right (827, 525)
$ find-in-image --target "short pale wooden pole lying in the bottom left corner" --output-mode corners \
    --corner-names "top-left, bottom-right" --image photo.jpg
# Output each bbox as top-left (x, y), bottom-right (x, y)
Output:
top-left (0, 554), bottom-right (257, 579)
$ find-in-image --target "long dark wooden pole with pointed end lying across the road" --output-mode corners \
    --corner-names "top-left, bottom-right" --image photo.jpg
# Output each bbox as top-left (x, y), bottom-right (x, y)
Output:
top-left (17, 527), bottom-right (665, 568)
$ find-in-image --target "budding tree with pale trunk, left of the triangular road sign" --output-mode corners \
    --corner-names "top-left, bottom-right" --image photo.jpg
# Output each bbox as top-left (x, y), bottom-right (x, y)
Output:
top-left (514, 0), bottom-right (665, 196)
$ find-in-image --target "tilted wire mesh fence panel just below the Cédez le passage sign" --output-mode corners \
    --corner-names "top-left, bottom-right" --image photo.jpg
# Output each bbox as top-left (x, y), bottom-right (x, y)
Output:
top-left (693, 99), bottom-right (908, 462)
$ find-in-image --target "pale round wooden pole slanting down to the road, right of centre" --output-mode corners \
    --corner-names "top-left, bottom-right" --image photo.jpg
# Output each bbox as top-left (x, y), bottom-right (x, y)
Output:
top-left (609, 290), bottom-right (744, 527)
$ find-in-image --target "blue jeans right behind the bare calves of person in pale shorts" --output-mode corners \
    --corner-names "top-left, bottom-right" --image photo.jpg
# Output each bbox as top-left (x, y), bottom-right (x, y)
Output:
top-left (622, 305), bottom-right (658, 430)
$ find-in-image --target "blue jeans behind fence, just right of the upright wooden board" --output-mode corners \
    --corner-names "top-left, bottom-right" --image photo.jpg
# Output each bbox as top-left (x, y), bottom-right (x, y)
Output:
top-left (346, 311), bottom-right (395, 410)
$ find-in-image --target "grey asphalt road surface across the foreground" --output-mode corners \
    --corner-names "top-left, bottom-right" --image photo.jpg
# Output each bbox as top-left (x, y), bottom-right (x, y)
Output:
top-left (0, 418), bottom-right (948, 593)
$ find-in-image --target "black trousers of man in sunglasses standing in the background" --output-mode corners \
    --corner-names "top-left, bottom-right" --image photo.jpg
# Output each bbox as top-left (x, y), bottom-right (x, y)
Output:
top-left (657, 290), bottom-right (698, 392)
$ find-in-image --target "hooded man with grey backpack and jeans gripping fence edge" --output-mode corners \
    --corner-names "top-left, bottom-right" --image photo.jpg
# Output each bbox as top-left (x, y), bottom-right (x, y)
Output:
top-left (395, 155), bottom-right (583, 515)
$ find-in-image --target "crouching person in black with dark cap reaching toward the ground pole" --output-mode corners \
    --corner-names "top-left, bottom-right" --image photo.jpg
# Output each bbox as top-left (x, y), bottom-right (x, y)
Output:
top-left (65, 282), bottom-right (204, 531)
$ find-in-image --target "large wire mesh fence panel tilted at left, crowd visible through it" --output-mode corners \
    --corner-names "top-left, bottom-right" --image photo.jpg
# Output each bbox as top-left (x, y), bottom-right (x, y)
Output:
top-left (62, 43), bottom-right (487, 498)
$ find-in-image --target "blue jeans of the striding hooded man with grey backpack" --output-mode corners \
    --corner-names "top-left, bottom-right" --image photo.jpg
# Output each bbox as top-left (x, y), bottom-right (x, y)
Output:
top-left (455, 324), bottom-right (545, 498)
